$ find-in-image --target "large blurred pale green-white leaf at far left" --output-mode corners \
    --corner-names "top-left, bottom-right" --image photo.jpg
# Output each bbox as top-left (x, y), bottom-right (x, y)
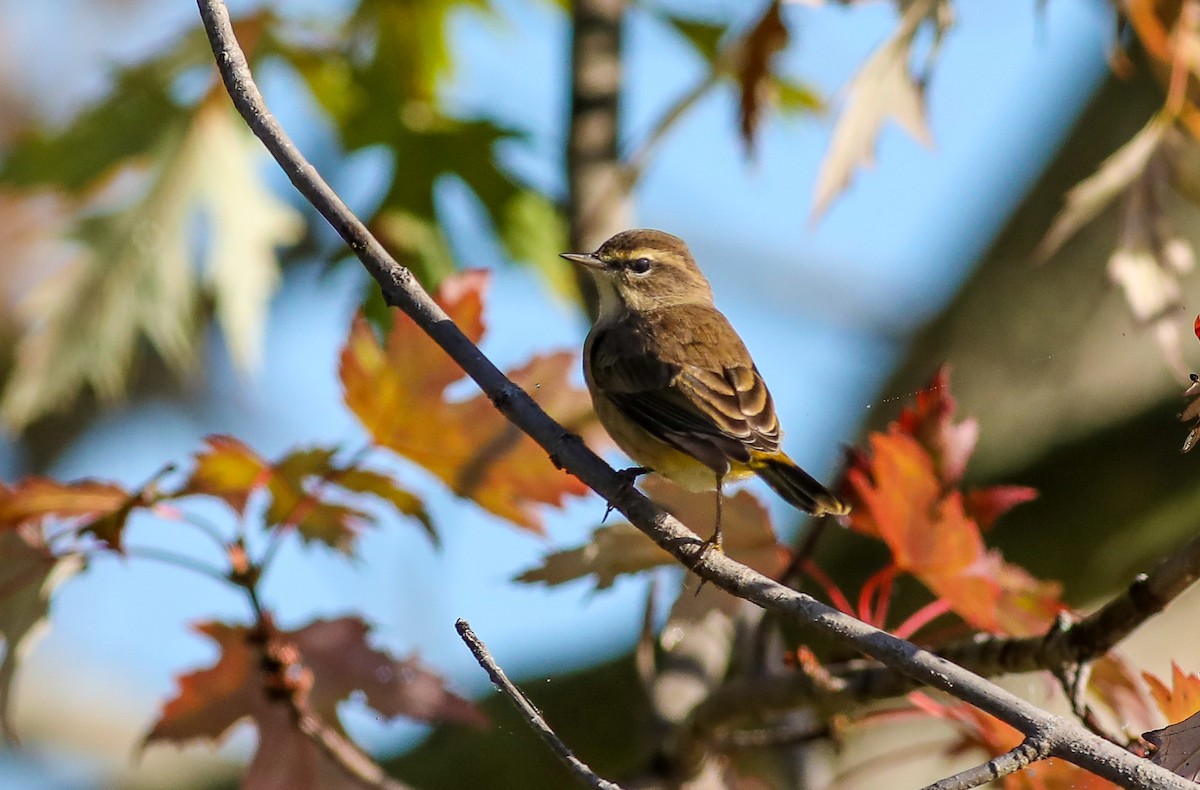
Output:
top-left (0, 98), bottom-right (302, 429)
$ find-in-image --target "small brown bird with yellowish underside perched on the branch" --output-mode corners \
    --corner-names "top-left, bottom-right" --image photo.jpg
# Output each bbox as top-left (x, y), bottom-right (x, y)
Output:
top-left (562, 229), bottom-right (850, 549)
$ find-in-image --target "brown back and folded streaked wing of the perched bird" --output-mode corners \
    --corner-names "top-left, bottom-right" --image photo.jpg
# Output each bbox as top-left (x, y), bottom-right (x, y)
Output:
top-left (590, 306), bottom-right (780, 473)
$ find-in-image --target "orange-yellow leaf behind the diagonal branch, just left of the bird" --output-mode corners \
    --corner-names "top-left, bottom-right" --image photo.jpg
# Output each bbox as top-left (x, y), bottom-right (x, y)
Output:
top-left (341, 271), bottom-right (595, 532)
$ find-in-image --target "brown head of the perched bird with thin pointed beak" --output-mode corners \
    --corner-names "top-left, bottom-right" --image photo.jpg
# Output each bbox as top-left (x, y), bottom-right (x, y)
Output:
top-left (563, 228), bottom-right (713, 316)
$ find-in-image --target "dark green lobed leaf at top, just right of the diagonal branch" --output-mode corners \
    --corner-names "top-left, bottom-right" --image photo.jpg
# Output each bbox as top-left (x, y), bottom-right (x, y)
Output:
top-left (280, 0), bottom-right (523, 287)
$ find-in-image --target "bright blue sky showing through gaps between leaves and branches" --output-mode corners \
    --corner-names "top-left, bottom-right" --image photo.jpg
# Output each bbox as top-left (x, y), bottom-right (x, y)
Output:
top-left (0, 0), bottom-right (1111, 786)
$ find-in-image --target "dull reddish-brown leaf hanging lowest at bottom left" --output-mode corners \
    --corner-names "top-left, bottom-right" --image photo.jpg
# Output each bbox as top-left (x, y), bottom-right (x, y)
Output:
top-left (144, 617), bottom-right (486, 790)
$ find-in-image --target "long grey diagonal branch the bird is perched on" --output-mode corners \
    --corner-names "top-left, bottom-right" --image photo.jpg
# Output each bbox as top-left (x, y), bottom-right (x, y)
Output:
top-left (197, 0), bottom-right (1198, 790)
